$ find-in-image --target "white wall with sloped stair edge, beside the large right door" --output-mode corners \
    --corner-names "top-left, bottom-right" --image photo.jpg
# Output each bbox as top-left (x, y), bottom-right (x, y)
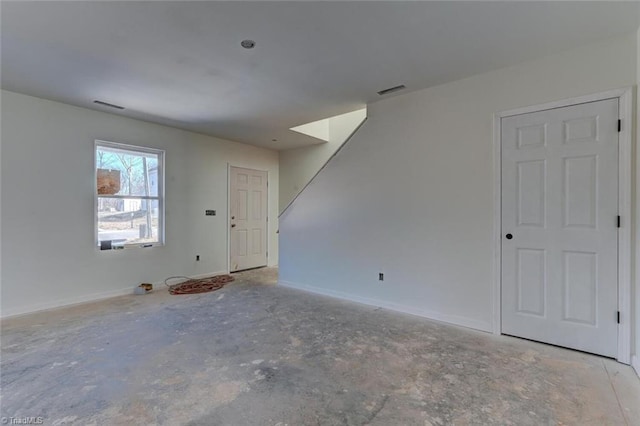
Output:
top-left (280, 33), bottom-right (637, 331)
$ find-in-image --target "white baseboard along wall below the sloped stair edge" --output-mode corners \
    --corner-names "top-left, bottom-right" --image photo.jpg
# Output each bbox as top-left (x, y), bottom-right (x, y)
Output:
top-left (278, 281), bottom-right (493, 333)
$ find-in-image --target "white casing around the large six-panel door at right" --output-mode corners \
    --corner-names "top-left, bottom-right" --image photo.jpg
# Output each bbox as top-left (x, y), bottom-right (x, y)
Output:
top-left (492, 87), bottom-right (633, 364)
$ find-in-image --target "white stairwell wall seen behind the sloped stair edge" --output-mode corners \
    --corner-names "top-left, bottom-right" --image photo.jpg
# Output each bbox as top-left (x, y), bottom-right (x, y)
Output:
top-left (280, 108), bottom-right (367, 211)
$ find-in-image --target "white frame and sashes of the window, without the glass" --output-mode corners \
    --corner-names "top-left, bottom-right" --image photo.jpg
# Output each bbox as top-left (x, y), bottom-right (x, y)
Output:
top-left (93, 139), bottom-right (165, 251)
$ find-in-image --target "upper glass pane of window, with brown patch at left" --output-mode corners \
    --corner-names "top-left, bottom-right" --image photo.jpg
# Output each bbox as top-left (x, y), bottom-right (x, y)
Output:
top-left (96, 146), bottom-right (159, 197)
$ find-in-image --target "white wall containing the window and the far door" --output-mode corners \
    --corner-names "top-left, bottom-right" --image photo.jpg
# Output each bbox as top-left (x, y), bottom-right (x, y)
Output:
top-left (1, 91), bottom-right (279, 316)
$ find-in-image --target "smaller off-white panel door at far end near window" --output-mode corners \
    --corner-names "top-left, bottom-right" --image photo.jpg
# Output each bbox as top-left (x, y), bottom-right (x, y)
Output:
top-left (229, 167), bottom-right (267, 272)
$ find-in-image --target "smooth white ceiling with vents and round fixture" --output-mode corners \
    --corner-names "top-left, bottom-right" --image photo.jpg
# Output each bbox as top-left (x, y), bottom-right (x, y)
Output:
top-left (1, 1), bottom-right (640, 149)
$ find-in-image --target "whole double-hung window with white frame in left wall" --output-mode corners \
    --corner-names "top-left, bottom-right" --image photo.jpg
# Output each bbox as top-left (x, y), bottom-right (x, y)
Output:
top-left (95, 141), bottom-right (164, 250)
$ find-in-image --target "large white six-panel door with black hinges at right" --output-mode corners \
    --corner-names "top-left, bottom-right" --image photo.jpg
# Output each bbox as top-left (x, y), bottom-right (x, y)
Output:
top-left (501, 99), bottom-right (618, 357)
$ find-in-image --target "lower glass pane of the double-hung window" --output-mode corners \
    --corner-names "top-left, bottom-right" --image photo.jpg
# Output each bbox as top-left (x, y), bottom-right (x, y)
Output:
top-left (97, 197), bottom-right (160, 246)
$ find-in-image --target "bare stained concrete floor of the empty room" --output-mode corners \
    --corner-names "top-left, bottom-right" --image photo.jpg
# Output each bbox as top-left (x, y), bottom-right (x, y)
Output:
top-left (0, 269), bottom-right (640, 426)
